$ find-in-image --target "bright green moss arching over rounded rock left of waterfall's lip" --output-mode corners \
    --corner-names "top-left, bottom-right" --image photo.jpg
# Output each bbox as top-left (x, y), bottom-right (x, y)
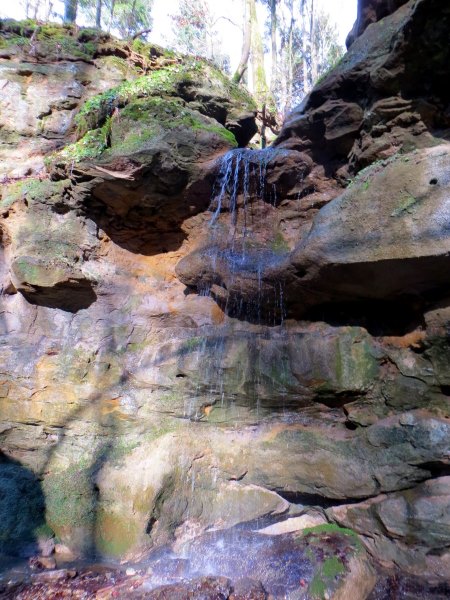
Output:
top-left (46, 45), bottom-right (248, 168)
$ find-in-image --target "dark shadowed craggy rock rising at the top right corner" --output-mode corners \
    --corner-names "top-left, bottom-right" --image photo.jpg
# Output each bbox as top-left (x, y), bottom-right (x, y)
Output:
top-left (276, 0), bottom-right (450, 178)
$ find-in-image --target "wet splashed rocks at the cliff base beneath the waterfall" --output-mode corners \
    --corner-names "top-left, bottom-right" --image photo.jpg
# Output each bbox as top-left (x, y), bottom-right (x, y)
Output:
top-left (0, 525), bottom-right (375, 600)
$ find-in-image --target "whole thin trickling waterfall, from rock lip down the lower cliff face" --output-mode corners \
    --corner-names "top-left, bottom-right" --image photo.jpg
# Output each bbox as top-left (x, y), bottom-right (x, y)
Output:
top-left (181, 148), bottom-right (294, 420)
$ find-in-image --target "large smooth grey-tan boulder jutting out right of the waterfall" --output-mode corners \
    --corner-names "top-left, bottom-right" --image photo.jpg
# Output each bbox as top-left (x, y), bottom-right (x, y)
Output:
top-left (292, 145), bottom-right (450, 310)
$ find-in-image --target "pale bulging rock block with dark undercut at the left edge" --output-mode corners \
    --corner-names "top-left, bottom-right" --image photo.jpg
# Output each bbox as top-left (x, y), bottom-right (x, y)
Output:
top-left (1, 179), bottom-right (98, 312)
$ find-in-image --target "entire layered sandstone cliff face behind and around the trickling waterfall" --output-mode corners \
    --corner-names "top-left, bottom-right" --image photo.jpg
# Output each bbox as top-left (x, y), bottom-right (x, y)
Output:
top-left (0, 9), bottom-right (450, 600)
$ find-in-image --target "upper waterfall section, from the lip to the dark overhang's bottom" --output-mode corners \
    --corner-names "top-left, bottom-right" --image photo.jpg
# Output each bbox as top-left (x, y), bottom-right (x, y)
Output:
top-left (199, 148), bottom-right (285, 324)
